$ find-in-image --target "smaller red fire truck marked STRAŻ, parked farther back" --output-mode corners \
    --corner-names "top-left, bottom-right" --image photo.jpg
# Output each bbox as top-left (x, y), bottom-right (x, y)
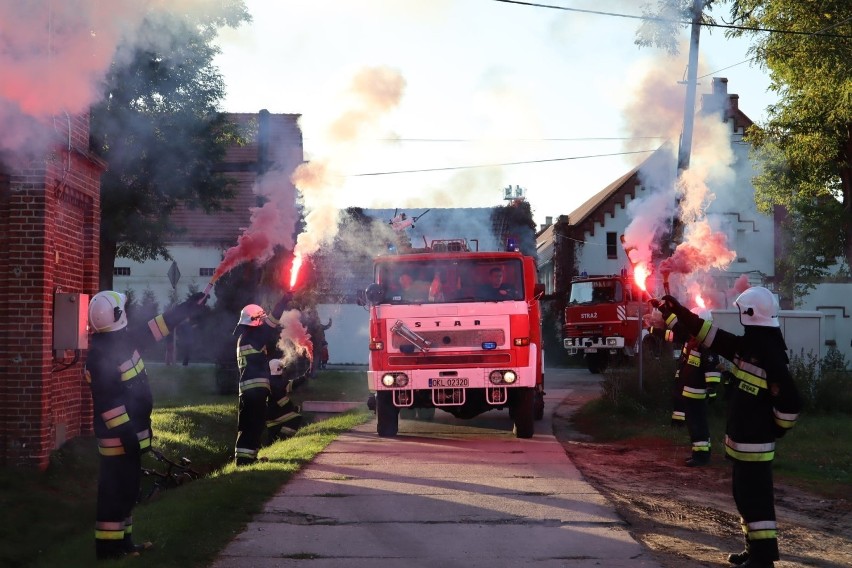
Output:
top-left (562, 275), bottom-right (659, 373)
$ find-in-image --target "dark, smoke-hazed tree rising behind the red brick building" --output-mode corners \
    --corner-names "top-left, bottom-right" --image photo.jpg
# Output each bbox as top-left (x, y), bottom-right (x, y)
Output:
top-left (90, 0), bottom-right (250, 289)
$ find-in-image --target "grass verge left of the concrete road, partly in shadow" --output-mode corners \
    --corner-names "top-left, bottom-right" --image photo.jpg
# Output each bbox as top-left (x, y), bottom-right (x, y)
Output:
top-left (0, 364), bottom-right (371, 568)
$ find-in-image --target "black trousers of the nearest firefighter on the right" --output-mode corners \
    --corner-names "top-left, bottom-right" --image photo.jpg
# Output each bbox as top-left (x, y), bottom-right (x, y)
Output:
top-left (731, 460), bottom-right (778, 562)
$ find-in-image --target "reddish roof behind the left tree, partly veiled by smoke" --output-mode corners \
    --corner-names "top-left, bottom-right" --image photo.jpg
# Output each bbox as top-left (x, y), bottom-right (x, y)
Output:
top-left (170, 111), bottom-right (304, 246)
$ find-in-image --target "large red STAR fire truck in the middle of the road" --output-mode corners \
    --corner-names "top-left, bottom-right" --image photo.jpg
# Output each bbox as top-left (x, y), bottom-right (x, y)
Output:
top-left (363, 239), bottom-right (544, 438)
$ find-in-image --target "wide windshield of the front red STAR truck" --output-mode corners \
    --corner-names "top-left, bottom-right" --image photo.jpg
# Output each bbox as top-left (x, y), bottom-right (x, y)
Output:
top-left (374, 258), bottom-right (524, 304)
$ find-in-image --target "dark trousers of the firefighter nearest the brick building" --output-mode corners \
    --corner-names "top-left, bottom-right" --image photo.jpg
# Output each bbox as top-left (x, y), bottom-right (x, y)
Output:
top-left (95, 452), bottom-right (142, 558)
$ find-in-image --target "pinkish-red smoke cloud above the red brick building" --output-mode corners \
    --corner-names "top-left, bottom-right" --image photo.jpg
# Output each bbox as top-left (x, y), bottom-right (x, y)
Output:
top-left (0, 0), bottom-right (233, 158)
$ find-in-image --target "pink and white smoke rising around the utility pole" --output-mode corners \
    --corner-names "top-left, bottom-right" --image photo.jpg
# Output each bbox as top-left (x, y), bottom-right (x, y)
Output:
top-left (624, 45), bottom-right (736, 298)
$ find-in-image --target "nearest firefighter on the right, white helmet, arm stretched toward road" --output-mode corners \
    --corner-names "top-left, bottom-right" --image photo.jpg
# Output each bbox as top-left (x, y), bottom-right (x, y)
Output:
top-left (654, 286), bottom-right (802, 568)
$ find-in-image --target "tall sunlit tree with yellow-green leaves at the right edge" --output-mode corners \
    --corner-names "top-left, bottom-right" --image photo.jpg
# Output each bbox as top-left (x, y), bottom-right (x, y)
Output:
top-left (726, 0), bottom-right (852, 295)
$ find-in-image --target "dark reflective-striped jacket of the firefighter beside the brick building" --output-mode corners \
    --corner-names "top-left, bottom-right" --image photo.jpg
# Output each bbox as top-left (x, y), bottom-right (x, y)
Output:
top-left (84, 299), bottom-right (201, 456)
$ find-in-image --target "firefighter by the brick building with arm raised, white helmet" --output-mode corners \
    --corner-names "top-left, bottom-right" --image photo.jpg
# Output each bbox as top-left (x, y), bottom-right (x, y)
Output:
top-left (85, 290), bottom-right (206, 560)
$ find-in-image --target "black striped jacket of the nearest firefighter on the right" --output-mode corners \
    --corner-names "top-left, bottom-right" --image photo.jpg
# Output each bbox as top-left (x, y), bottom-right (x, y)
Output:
top-left (666, 304), bottom-right (802, 462)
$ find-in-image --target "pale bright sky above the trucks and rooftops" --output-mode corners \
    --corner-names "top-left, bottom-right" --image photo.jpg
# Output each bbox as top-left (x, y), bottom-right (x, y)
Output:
top-left (210, 0), bottom-right (775, 231)
